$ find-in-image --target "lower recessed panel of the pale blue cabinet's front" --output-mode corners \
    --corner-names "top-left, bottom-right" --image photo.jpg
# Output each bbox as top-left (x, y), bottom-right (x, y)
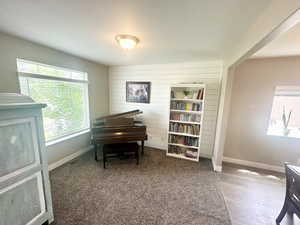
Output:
top-left (0, 172), bottom-right (45, 225)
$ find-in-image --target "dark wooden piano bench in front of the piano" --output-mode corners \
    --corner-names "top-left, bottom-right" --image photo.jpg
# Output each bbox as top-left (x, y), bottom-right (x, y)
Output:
top-left (103, 142), bottom-right (139, 169)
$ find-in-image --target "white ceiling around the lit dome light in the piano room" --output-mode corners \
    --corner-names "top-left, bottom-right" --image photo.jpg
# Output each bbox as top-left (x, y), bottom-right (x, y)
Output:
top-left (0, 0), bottom-right (270, 65)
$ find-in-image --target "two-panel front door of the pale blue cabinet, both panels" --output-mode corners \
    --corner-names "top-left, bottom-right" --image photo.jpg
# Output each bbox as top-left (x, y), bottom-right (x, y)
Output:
top-left (0, 117), bottom-right (45, 225)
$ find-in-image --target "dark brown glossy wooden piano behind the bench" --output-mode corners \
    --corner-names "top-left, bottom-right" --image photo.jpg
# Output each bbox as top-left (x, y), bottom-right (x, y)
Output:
top-left (92, 110), bottom-right (147, 161)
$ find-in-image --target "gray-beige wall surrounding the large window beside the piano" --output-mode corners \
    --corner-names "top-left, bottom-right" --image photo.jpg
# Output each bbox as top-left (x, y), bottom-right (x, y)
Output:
top-left (0, 33), bottom-right (109, 163)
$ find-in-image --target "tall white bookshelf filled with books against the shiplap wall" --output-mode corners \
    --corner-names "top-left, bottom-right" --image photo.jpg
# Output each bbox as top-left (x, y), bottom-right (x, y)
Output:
top-left (167, 84), bottom-right (205, 162)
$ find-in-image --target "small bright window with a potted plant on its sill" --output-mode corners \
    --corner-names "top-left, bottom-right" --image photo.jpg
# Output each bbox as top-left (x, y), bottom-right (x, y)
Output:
top-left (268, 86), bottom-right (300, 138)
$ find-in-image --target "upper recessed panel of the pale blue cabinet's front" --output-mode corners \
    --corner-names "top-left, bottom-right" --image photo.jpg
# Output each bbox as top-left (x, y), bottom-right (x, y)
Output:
top-left (0, 118), bottom-right (40, 179)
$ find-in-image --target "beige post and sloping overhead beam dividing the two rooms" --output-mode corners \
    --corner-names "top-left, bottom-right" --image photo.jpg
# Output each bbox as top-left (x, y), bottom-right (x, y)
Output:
top-left (213, 0), bottom-right (300, 170)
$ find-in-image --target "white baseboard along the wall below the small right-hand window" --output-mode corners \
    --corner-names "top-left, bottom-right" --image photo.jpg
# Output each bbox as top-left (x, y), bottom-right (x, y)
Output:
top-left (223, 157), bottom-right (284, 173)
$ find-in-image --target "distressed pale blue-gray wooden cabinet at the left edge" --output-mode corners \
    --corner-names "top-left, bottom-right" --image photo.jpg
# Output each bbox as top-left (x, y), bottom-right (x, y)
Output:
top-left (0, 94), bottom-right (53, 225)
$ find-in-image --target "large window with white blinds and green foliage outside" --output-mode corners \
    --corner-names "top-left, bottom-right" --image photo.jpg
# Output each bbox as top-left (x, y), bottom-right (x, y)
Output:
top-left (17, 59), bottom-right (90, 144)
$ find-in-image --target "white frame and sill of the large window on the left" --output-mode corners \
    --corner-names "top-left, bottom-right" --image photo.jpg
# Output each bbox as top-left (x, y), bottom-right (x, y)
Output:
top-left (16, 58), bottom-right (91, 146)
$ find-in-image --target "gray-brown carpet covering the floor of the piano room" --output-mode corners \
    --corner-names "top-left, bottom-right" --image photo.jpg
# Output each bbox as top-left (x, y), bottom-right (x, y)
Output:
top-left (50, 149), bottom-right (231, 225)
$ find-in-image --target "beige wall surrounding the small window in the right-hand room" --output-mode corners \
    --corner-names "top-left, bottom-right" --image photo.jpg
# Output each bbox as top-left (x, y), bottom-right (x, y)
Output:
top-left (224, 57), bottom-right (300, 166)
